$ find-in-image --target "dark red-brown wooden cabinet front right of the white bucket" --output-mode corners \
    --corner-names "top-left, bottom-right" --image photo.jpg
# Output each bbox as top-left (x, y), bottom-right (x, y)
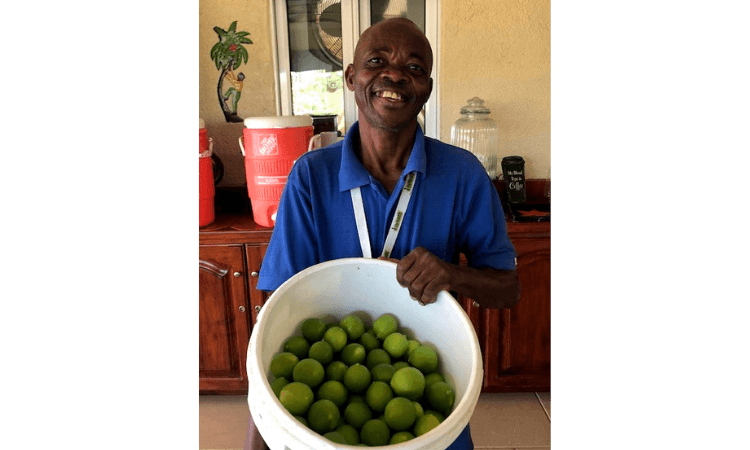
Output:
top-left (482, 236), bottom-right (551, 392)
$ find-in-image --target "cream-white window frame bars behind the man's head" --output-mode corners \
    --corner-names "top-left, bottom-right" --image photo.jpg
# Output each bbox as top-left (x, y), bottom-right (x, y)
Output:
top-left (269, 0), bottom-right (440, 139)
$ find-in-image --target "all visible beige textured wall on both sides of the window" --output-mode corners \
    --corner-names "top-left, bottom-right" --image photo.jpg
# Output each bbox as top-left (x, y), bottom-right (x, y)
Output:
top-left (198, 0), bottom-right (552, 186)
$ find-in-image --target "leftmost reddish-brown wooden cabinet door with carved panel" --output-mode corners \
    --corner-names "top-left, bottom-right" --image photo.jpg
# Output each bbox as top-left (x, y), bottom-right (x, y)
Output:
top-left (198, 245), bottom-right (250, 393)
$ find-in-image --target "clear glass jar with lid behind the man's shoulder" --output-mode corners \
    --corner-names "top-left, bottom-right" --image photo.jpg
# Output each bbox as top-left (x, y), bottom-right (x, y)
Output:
top-left (451, 97), bottom-right (500, 180)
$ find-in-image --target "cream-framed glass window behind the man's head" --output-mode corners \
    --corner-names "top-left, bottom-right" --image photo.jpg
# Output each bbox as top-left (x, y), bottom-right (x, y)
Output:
top-left (273, 0), bottom-right (439, 138)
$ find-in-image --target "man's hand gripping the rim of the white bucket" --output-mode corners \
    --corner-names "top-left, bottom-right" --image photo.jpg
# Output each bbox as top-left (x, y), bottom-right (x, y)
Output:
top-left (383, 247), bottom-right (453, 305)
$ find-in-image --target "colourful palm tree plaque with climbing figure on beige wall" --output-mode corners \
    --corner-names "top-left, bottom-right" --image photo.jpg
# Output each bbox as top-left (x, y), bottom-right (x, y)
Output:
top-left (211, 20), bottom-right (253, 122)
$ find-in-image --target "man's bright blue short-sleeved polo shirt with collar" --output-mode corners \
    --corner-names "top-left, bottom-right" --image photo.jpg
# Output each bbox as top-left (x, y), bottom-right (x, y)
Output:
top-left (257, 123), bottom-right (515, 291)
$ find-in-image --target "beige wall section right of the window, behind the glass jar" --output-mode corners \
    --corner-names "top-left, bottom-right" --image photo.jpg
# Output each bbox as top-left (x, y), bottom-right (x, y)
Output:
top-left (439, 0), bottom-right (552, 178)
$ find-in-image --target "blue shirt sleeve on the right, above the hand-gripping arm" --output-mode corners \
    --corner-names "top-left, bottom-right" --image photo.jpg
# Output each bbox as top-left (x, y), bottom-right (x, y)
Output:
top-left (459, 165), bottom-right (516, 270)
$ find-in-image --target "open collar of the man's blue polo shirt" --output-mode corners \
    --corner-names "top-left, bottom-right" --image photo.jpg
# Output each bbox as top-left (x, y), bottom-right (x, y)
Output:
top-left (339, 122), bottom-right (427, 192)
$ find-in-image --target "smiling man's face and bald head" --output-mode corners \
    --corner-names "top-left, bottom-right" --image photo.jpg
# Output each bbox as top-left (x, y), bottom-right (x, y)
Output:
top-left (345, 20), bottom-right (432, 131)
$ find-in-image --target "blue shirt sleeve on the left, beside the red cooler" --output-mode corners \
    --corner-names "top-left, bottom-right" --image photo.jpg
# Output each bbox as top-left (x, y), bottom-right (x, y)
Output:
top-left (257, 161), bottom-right (319, 291)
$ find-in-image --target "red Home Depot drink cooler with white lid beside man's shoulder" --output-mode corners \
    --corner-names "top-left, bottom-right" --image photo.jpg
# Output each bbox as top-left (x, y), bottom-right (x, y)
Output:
top-left (240, 116), bottom-right (313, 227)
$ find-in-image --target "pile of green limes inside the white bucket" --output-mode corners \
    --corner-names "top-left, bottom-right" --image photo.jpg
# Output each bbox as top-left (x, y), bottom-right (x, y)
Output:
top-left (270, 314), bottom-right (456, 446)
